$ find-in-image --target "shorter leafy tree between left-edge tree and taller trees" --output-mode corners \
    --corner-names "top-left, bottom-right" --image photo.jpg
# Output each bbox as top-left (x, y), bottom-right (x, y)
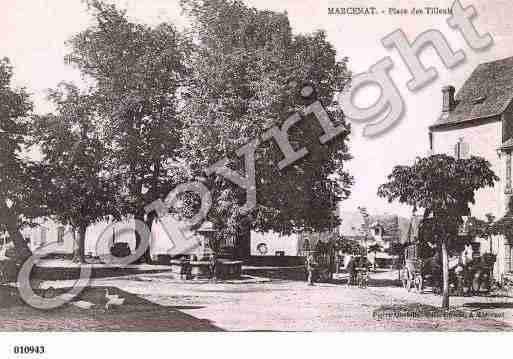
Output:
top-left (32, 83), bottom-right (119, 262)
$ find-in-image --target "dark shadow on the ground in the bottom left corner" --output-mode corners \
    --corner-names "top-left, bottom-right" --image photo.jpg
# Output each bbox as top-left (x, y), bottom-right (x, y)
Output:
top-left (0, 286), bottom-right (221, 332)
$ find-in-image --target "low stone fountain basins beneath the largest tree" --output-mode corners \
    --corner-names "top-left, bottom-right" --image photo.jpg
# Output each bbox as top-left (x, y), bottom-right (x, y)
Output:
top-left (169, 259), bottom-right (243, 279)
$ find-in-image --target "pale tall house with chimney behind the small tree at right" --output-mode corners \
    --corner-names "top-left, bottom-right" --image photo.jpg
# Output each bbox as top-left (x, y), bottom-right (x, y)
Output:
top-left (429, 57), bottom-right (513, 281)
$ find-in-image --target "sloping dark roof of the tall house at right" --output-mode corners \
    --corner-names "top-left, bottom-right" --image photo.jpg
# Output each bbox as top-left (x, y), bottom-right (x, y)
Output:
top-left (431, 57), bottom-right (513, 127)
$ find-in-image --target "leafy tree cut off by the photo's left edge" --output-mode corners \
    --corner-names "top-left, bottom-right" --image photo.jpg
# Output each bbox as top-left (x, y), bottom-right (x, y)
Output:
top-left (0, 58), bottom-right (43, 261)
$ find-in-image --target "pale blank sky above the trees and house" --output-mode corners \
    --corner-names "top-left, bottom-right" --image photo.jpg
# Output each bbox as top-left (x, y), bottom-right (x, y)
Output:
top-left (0, 0), bottom-right (513, 217)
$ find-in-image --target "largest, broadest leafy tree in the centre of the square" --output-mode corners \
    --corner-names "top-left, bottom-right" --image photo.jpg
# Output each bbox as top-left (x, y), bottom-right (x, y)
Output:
top-left (180, 0), bottom-right (352, 255)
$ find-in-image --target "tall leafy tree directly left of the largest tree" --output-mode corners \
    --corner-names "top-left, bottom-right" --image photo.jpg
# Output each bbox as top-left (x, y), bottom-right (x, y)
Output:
top-left (66, 0), bottom-right (189, 260)
